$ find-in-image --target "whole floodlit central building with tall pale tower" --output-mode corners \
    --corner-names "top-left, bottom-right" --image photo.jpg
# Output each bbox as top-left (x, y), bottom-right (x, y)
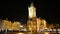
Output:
top-left (27, 3), bottom-right (46, 32)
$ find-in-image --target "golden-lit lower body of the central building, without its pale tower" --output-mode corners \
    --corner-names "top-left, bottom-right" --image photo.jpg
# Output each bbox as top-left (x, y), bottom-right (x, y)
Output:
top-left (27, 18), bottom-right (46, 31)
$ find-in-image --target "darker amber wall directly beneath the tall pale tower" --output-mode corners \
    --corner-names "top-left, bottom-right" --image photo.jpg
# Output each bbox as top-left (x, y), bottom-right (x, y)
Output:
top-left (27, 18), bottom-right (37, 31)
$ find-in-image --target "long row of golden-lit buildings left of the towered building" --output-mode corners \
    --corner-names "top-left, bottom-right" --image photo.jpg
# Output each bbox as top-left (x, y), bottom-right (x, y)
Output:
top-left (0, 20), bottom-right (21, 30)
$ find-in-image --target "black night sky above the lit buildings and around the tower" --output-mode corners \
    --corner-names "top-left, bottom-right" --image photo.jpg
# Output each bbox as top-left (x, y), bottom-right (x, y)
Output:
top-left (0, 0), bottom-right (60, 23)
